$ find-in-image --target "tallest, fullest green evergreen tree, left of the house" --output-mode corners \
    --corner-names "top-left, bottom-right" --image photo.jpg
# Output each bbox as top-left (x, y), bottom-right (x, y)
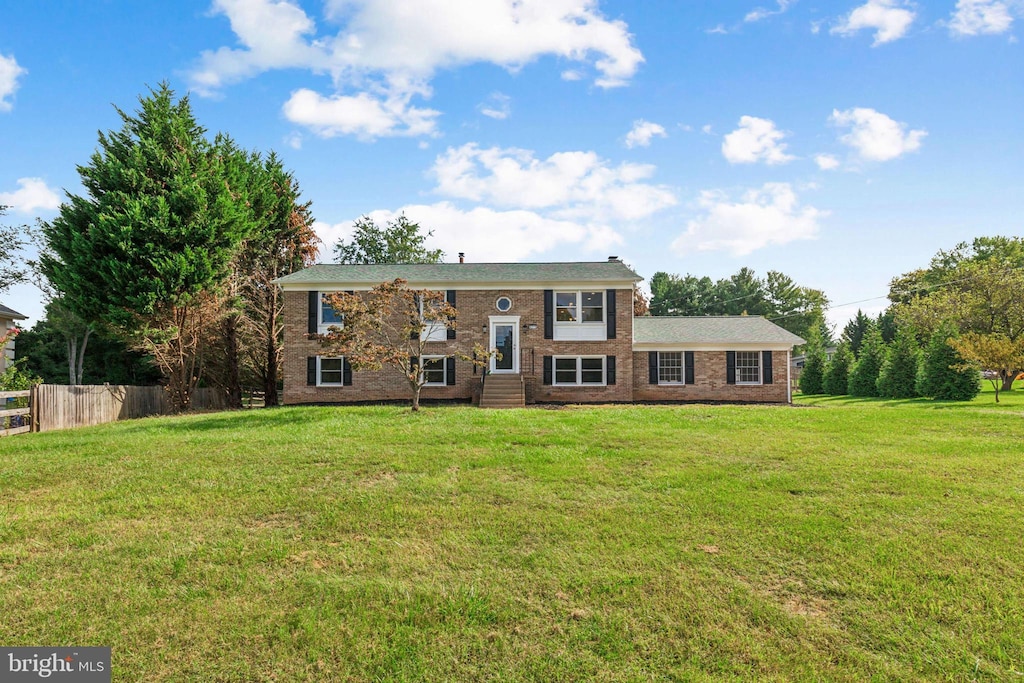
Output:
top-left (41, 83), bottom-right (247, 409)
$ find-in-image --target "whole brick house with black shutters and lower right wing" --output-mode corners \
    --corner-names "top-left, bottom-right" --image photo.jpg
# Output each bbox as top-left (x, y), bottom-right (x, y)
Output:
top-left (278, 257), bottom-right (803, 407)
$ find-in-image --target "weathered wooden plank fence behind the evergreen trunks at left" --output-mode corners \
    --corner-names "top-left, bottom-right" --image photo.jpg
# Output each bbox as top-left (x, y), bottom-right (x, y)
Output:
top-left (31, 384), bottom-right (224, 431)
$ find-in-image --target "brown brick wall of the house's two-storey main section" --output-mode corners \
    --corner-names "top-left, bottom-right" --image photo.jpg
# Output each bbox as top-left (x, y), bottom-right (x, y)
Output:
top-left (284, 290), bottom-right (633, 403)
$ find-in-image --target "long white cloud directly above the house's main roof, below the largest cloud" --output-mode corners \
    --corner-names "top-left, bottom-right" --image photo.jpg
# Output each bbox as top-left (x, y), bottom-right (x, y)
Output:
top-left (431, 143), bottom-right (676, 221)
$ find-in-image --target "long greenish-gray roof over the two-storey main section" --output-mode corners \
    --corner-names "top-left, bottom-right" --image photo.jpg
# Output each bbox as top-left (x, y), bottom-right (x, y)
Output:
top-left (276, 260), bottom-right (643, 289)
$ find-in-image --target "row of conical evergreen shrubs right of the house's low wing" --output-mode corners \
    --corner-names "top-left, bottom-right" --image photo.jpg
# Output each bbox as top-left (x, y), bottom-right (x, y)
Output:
top-left (800, 327), bottom-right (981, 400)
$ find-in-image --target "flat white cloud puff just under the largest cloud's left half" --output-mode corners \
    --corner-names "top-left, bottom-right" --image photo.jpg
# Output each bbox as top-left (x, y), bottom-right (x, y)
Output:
top-left (283, 88), bottom-right (440, 139)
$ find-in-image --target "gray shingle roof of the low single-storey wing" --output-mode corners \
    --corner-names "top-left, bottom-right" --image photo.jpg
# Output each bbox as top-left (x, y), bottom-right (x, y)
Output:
top-left (633, 315), bottom-right (804, 346)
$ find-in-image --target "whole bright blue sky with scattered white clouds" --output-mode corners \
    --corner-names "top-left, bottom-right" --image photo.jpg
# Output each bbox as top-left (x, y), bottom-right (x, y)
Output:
top-left (0, 0), bottom-right (1024, 325)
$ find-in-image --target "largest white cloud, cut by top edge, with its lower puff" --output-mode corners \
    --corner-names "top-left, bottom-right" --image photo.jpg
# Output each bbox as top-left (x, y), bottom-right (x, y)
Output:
top-left (189, 0), bottom-right (643, 138)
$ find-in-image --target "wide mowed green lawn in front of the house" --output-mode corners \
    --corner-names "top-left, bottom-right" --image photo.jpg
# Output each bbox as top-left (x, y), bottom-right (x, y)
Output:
top-left (0, 390), bottom-right (1024, 681)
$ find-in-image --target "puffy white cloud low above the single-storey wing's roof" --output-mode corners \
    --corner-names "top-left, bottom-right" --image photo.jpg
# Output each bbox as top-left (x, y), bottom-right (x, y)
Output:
top-left (672, 182), bottom-right (828, 256)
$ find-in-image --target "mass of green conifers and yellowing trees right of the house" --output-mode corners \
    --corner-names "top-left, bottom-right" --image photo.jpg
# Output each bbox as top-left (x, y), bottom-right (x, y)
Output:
top-left (800, 237), bottom-right (1024, 402)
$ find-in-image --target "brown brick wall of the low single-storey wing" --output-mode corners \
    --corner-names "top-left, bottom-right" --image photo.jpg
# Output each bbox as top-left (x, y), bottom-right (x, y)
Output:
top-left (633, 351), bottom-right (786, 403)
